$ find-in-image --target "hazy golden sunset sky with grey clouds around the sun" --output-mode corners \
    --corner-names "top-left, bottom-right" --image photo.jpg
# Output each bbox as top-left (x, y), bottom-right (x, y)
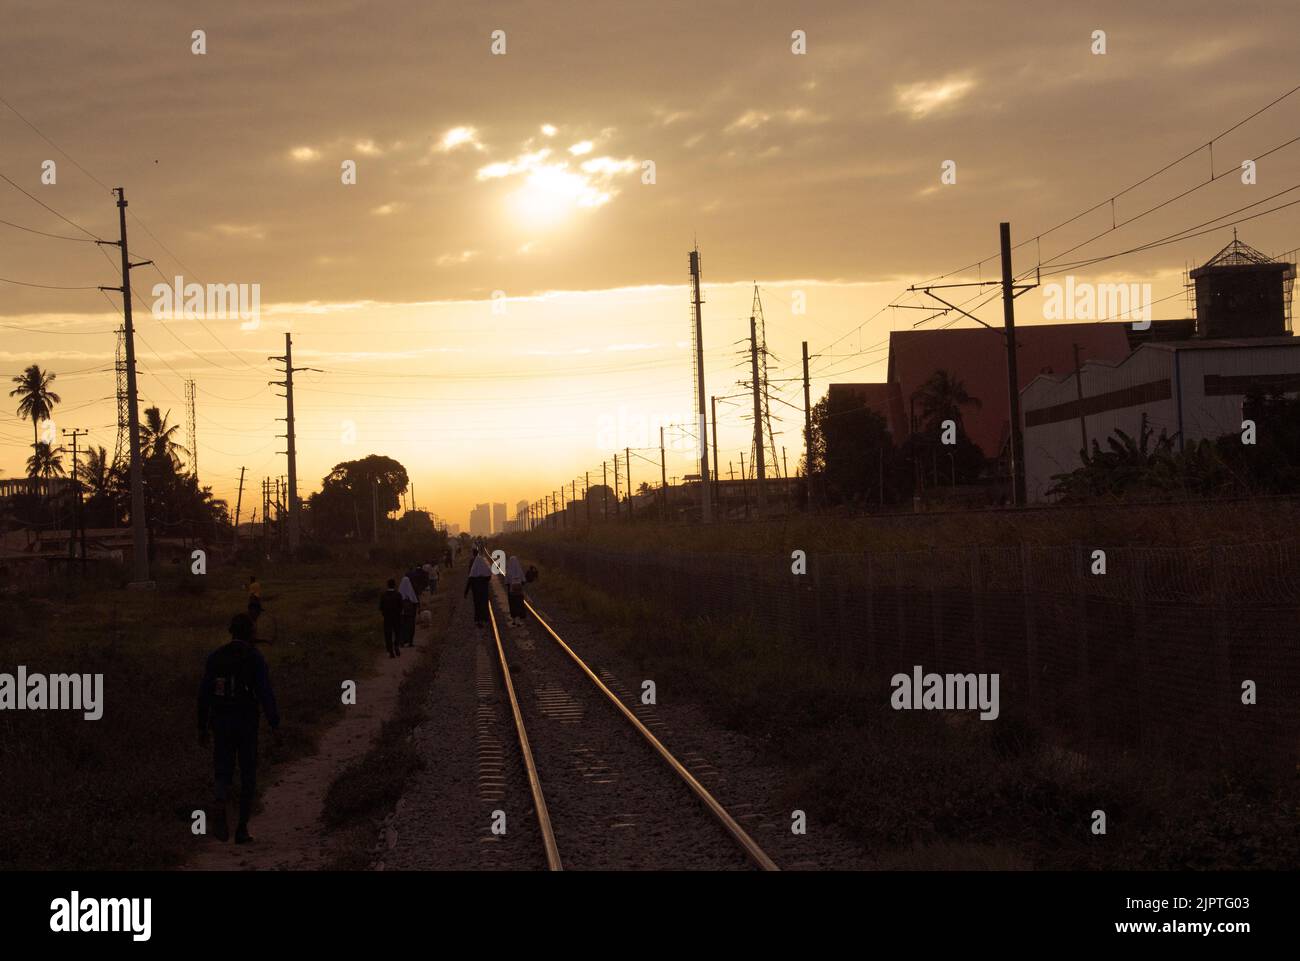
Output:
top-left (0, 0), bottom-right (1300, 525)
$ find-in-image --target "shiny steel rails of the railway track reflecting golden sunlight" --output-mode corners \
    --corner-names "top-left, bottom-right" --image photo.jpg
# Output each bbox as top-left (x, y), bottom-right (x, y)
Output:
top-left (489, 582), bottom-right (780, 871)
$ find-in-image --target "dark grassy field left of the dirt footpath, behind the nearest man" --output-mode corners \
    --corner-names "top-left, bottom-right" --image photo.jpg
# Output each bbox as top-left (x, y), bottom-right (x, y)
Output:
top-left (0, 548), bottom-right (410, 870)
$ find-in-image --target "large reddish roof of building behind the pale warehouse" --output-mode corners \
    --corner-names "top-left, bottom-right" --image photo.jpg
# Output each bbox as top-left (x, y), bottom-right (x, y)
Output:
top-left (872, 323), bottom-right (1130, 456)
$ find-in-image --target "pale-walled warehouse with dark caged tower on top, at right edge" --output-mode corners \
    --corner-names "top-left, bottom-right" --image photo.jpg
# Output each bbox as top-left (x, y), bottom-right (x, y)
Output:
top-left (1021, 238), bottom-right (1300, 501)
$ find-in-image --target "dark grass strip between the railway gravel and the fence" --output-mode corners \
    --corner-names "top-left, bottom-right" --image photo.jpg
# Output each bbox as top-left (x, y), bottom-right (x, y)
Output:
top-left (522, 559), bottom-right (1300, 869)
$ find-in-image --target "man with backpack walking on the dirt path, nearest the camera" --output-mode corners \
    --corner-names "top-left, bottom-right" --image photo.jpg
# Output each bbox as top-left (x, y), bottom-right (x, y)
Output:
top-left (199, 614), bottom-right (280, 844)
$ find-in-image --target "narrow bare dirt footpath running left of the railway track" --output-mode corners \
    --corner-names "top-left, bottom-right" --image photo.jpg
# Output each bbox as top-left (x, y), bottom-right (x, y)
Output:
top-left (186, 616), bottom-right (430, 871)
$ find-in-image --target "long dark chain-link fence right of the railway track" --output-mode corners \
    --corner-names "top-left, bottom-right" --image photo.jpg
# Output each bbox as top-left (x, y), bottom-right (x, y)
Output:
top-left (528, 541), bottom-right (1300, 767)
